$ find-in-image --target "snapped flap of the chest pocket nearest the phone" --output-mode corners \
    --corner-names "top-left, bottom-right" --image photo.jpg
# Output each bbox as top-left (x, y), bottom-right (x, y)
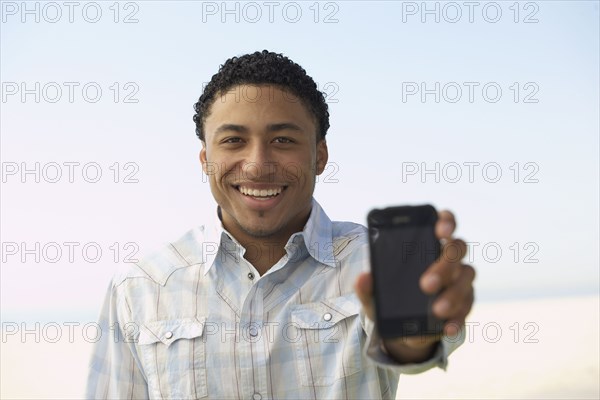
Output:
top-left (292, 293), bottom-right (361, 329)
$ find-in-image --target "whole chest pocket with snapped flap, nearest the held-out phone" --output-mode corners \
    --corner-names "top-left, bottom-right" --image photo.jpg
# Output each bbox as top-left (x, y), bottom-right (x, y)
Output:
top-left (291, 294), bottom-right (365, 386)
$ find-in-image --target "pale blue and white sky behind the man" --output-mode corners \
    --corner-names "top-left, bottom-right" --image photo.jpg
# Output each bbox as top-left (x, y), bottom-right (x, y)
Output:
top-left (0, 1), bottom-right (600, 318)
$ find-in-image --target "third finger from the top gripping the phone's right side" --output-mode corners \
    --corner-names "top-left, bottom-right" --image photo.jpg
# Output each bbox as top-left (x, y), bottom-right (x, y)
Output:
top-left (433, 265), bottom-right (475, 320)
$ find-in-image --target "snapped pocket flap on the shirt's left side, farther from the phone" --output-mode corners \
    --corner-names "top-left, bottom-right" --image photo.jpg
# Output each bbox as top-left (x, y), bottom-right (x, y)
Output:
top-left (138, 318), bottom-right (206, 346)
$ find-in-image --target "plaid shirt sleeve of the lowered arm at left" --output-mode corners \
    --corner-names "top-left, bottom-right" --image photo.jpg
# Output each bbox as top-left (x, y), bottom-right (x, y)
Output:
top-left (85, 284), bottom-right (149, 399)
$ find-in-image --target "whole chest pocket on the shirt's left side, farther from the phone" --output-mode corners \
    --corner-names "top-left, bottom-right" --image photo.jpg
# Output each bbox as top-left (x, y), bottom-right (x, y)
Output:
top-left (138, 318), bottom-right (208, 399)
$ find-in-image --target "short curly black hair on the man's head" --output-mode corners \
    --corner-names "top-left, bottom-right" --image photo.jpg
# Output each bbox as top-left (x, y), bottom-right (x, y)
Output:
top-left (193, 50), bottom-right (329, 141)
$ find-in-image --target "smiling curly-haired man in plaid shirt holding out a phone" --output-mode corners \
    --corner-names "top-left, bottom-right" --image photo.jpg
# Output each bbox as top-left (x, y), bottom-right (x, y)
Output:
top-left (87, 50), bottom-right (474, 399)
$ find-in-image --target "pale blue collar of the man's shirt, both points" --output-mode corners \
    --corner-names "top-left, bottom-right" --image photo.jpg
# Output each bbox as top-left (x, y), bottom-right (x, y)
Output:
top-left (202, 198), bottom-right (336, 274)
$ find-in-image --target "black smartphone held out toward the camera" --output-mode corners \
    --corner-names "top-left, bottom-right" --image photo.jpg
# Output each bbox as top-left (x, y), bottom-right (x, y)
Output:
top-left (367, 205), bottom-right (444, 338)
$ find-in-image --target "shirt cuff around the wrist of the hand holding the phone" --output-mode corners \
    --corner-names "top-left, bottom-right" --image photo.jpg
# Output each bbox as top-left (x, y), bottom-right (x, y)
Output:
top-left (365, 318), bottom-right (465, 374)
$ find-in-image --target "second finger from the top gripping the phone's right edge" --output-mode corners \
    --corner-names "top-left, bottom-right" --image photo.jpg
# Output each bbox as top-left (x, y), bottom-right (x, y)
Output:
top-left (419, 239), bottom-right (467, 294)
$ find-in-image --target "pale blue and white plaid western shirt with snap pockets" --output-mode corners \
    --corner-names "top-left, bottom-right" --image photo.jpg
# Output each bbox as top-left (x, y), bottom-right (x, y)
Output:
top-left (86, 200), bottom-right (464, 400)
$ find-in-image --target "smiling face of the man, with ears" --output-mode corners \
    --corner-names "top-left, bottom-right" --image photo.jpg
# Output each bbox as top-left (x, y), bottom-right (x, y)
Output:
top-left (200, 85), bottom-right (328, 240)
